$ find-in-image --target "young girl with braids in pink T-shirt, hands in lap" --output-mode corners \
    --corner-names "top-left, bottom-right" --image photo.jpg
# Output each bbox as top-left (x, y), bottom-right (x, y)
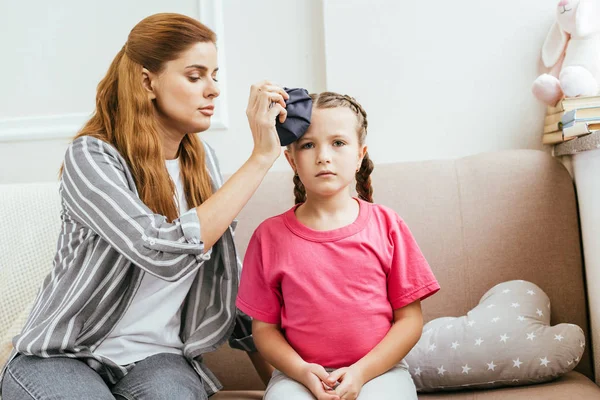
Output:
top-left (237, 92), bottom-right (439, 400)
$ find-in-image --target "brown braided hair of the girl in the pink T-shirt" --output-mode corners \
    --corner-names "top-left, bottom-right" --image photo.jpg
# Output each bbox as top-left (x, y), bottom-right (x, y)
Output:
top-left (288, 92), bottom-right (373, 204)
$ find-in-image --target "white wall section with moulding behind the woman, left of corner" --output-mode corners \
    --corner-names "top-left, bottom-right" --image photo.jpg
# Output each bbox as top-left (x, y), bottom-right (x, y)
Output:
top-left (0, 0), bottom-right (325, 183)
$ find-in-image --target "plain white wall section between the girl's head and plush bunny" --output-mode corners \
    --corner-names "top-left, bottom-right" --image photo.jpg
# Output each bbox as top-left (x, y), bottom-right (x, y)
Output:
top-left (324, 0), bottom-right (557, 162)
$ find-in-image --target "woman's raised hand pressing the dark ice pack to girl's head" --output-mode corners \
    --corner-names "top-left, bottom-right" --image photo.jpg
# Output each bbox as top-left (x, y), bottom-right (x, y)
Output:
top-left (246, 81), bottom-right (290, 164)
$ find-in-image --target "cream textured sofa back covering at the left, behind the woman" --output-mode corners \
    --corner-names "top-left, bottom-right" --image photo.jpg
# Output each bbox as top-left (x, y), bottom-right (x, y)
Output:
top-left (0, 183), bottom-right (60, 366)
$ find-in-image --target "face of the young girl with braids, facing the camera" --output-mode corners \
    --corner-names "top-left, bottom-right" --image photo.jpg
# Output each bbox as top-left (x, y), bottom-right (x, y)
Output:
top-left (285, 107), bottom-right (367, 197)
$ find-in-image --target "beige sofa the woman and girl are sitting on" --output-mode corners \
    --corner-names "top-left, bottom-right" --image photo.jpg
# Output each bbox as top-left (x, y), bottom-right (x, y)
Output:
top-left (0, 150), bottom-right (600, 400)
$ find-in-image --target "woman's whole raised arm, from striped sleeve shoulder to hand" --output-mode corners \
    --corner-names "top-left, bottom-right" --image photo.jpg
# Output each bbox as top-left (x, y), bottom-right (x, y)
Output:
top-left (61, 83), bottom-right (287, 281)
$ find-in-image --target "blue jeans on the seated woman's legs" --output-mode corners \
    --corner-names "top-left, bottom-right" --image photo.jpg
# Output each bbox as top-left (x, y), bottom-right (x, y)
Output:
top-left (2, 353), bottom-right (208, 400)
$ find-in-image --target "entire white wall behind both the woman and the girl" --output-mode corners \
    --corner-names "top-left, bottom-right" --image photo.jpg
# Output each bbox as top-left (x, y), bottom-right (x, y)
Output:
top-left (0, 0), bottom-right (555, 183)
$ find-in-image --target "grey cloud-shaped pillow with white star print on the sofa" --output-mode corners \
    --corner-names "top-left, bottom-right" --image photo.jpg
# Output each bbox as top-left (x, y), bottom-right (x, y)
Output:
top-left (405, 281), bottom-right (585, 392)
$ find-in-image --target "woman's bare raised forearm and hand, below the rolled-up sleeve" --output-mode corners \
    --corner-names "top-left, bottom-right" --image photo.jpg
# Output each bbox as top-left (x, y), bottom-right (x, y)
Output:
top-left (196, 81), bottom-right (289, 251)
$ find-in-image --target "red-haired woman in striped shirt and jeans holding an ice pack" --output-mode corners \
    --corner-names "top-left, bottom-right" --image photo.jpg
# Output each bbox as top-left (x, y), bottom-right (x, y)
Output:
top-left (0, 14), bottom-right (288, 400)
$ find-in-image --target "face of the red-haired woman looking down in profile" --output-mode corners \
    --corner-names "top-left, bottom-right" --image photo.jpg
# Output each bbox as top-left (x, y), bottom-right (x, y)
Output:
top-left (144, 42), bottom-right (220, 135)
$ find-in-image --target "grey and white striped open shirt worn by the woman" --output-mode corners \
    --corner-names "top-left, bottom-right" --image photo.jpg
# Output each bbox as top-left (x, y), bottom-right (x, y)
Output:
top-left (0, 136), bottom-right (256, 395)
